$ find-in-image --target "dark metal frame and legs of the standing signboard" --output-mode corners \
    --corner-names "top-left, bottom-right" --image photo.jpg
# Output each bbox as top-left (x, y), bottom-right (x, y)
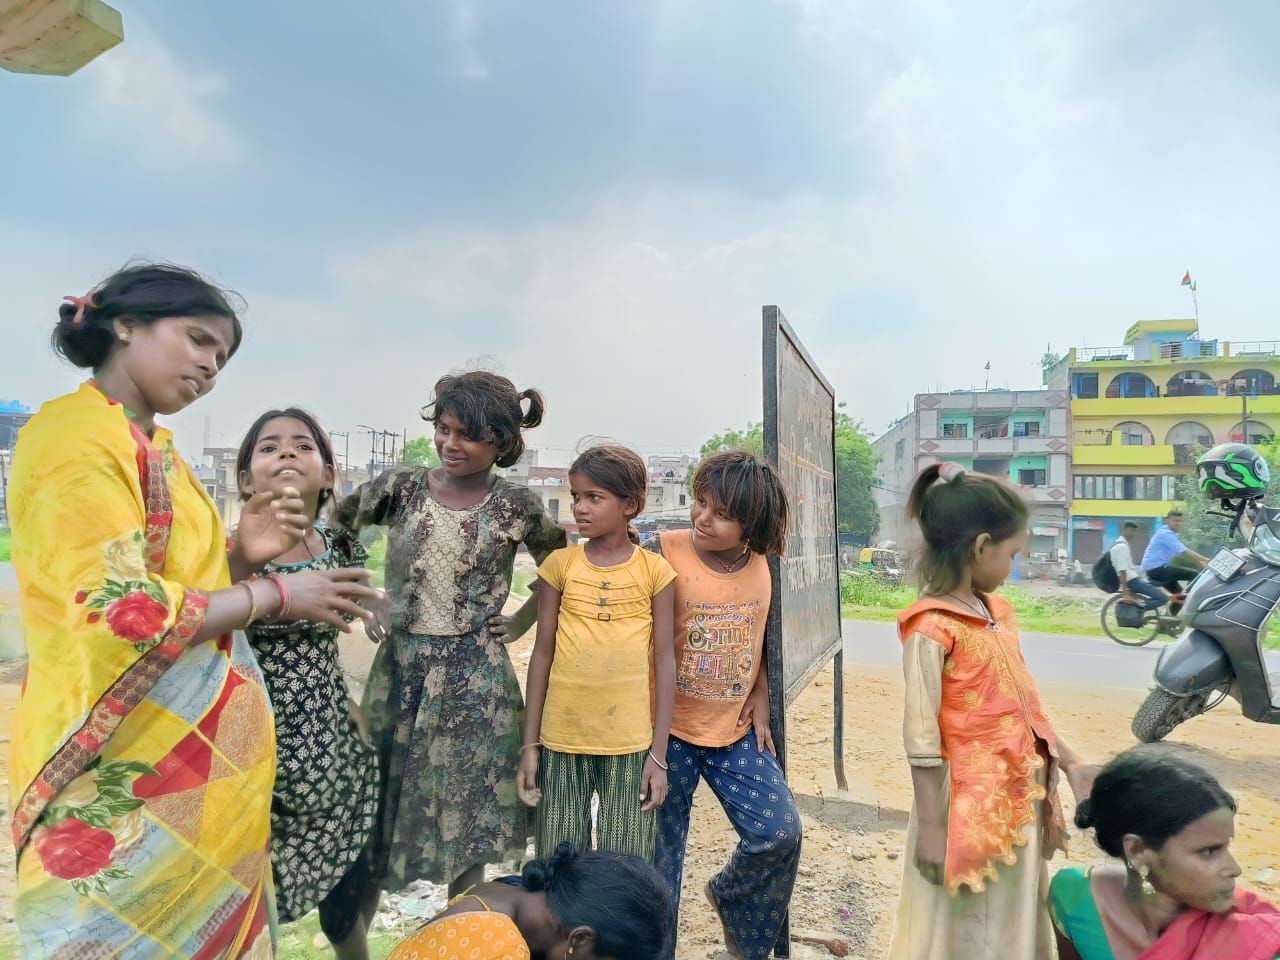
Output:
top-left (763, 306), bottom-right (849, 957)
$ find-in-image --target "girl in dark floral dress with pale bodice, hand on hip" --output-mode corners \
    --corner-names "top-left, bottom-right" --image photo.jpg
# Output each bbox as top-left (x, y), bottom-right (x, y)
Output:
top-left (333, 371), bottom-right (566, 896)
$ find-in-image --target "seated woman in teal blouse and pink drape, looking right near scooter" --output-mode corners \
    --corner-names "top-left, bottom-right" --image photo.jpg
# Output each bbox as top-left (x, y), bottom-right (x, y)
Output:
top-left (1050, 750), bottom-right (1280, 960)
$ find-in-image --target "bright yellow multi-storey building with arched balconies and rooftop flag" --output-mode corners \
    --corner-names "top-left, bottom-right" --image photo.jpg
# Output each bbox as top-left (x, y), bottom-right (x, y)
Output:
top-left (1044, 320), bottom-right (1280, 561)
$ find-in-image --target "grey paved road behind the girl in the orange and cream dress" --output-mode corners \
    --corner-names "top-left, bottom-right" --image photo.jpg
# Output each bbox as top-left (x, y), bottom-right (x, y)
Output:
top-left (844, 620), bottom-right (1164, 690)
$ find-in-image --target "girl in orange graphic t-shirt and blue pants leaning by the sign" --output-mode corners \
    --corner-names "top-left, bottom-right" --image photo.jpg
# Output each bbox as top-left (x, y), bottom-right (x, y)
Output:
top-left (649, 452), bottom-right (801, 959)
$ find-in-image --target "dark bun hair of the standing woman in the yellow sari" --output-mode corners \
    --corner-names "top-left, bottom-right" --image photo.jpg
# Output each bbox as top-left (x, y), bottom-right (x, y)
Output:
top-left (52, 264), bottom-right (243, 370)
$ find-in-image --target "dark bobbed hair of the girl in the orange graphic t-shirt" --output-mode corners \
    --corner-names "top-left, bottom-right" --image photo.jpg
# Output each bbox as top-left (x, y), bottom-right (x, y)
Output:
top-left (694, 451), bottom-right (791, 557)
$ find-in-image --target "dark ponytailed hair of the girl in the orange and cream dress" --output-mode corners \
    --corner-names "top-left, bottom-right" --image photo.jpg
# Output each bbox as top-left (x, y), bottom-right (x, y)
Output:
top-left (906, 463), bottom-right (1030, 594)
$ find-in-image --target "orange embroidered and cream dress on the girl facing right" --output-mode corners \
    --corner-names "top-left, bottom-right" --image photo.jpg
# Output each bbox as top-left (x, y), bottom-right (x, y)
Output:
top-left (888, 596), bottom-right (1065, 960)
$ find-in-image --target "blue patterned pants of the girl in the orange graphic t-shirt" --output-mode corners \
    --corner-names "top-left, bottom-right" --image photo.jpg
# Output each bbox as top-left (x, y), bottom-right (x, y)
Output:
top-left (657, 731), bottom-right (801, 960)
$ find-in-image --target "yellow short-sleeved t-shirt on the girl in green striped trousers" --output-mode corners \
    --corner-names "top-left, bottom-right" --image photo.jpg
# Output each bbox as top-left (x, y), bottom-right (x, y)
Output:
top-left (538, 544), bottom-right (676, 756)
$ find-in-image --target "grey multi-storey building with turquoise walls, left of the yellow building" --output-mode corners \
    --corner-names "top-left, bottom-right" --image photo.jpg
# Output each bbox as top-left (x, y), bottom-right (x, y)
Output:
top-left (873, 389), bottom-right (1070, 558)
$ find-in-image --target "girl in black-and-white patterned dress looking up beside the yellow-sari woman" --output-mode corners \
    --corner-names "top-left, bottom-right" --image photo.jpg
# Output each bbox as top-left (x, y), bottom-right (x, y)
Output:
top-left (236, 408), bottom-right (378, 960)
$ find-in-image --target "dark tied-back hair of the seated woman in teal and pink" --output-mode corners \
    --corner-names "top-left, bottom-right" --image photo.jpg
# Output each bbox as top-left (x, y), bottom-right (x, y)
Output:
top-left (1075, 748), bottom-right (1235, 859)
